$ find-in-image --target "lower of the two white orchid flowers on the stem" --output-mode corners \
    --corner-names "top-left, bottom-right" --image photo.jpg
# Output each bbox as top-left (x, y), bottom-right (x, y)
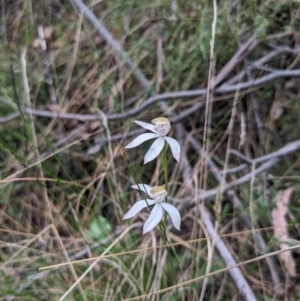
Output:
top-left (123, 184), bottom-right (181, 234)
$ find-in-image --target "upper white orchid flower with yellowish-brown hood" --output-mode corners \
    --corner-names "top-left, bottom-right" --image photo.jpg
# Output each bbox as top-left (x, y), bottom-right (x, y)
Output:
top-left (125, 117), bottom-right (181, 164)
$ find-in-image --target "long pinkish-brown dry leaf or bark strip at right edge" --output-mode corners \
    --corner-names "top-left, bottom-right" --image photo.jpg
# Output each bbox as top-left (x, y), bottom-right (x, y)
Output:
top-left (271, 188), bottom-right (296, 277)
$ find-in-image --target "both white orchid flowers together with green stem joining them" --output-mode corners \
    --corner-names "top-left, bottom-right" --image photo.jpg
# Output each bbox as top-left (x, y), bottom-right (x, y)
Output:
top-left (123, 117), bottom-right (181, 234)
